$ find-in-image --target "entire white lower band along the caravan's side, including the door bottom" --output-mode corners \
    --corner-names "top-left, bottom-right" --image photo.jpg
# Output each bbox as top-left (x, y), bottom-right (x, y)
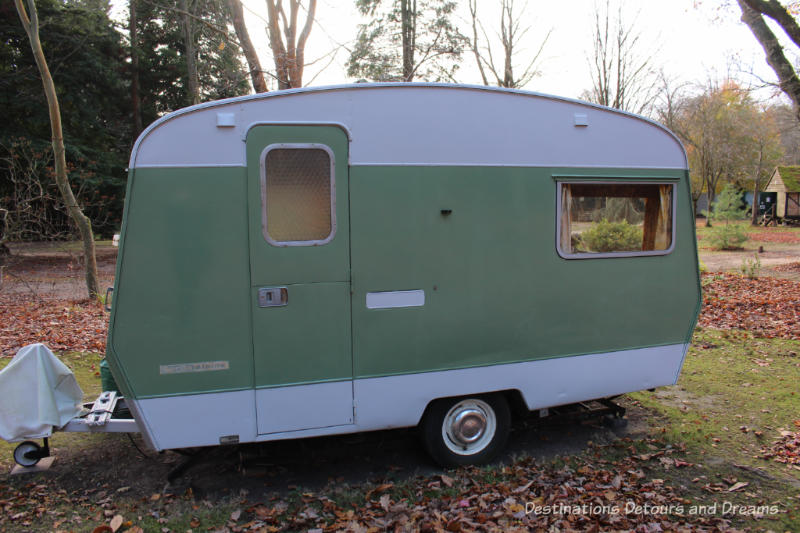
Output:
top-left (134, 344), bottom-right (688, 450)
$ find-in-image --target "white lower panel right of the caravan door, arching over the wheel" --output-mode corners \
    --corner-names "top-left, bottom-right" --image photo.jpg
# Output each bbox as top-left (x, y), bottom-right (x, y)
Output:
top-left (354, 344), bottom-right (688, 429)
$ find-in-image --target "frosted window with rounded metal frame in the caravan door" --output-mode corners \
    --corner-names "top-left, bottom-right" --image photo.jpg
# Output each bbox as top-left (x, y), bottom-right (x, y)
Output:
top-left (261, 144), bottom-right (336, 246)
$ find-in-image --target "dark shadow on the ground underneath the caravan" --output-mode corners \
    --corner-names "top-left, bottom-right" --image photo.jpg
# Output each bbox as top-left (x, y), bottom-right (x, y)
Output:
top-left (9, 406), bottom-right (646, 501)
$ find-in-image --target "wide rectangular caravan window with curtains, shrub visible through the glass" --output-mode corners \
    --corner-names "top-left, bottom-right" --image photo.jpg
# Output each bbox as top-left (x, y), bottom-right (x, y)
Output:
top-left (557, 182), bottom-right (675, 259)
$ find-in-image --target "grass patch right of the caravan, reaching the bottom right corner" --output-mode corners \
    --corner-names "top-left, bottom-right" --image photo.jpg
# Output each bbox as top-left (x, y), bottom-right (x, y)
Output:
top-left (630, 329), bottom-right (800, 531)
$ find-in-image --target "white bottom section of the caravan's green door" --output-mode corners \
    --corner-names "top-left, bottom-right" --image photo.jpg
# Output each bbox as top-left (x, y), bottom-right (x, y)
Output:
top-left (256, 381), bottom-right (353, 434)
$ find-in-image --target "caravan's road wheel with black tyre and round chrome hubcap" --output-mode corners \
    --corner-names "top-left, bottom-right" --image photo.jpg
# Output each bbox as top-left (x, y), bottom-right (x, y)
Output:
top-left (421, 394), bottom-right (511, 466)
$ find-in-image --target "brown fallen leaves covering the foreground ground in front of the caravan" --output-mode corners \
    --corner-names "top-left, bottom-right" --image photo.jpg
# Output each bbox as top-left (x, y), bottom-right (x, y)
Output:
top-left (0, 439), bottom-right (787, 532)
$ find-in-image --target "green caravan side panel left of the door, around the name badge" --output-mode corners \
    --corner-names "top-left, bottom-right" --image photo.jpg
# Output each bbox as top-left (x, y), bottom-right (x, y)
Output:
top-left (107, 168), bottom-right (253, 398)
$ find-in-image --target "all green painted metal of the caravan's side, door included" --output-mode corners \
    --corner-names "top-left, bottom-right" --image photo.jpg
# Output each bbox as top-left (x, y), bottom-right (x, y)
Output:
top-left (108, 158), bottom-right (700, 398)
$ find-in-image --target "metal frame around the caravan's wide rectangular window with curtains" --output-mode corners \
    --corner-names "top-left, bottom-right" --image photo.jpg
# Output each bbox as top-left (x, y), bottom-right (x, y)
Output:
top-left (556, 177), bottom-right (679, 259)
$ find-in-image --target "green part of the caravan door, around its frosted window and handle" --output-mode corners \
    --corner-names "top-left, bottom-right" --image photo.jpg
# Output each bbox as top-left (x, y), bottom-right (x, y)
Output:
top-left (247, 126), bottom-right (353, 388)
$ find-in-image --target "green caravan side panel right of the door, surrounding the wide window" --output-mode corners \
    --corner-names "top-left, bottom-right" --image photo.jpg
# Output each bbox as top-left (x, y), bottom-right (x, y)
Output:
top-left (350, 166), bottom-right (699, 377)
